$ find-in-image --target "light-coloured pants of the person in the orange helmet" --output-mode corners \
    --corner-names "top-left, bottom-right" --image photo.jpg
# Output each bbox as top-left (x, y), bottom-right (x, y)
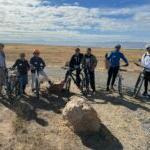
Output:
top-left (31, 70), bottom-right (50, 89)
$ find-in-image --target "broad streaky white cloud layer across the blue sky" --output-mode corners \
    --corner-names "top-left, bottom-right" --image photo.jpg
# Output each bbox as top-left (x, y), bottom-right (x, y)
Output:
top-left (0, 0), bottom-right (150, 42)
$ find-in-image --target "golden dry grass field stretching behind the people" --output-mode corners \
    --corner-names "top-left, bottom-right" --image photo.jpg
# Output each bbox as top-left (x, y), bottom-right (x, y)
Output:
top-left (5, 44), bottom-right (144, 70)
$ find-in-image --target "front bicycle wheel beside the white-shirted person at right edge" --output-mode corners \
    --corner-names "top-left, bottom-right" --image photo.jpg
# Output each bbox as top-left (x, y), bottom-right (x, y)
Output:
top-left (134, 74), bottom-right (144, 98)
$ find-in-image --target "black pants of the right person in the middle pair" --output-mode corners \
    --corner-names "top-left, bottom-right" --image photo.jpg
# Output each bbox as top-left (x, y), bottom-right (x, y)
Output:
top-left (84, 69), bottom-right (96, 92)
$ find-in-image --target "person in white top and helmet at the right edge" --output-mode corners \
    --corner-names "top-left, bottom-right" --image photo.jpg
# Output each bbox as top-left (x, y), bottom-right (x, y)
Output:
top-left (141, 45), bottom-right (150, 96)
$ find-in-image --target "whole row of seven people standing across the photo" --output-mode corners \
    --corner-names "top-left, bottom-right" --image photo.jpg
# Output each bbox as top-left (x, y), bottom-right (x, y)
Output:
top-left (0, 44), bottom-right (150, 96)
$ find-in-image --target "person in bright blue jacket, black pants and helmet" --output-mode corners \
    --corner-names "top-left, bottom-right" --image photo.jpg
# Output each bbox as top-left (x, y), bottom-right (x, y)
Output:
top-left (106, 45), bottom-right (129, 91)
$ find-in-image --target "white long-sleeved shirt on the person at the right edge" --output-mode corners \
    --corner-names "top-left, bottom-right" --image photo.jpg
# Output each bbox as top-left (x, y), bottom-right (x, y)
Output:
top-left (141, 52), bottom-right (150, 72)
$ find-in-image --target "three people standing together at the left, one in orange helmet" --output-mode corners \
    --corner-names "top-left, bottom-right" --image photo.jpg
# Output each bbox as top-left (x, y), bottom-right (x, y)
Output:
top-left (0, 44), bottom-right (52, 94)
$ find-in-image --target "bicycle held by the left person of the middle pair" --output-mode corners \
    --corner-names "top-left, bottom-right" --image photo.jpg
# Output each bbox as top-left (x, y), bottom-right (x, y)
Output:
top-left (62, 67), bottom-right (87, 94)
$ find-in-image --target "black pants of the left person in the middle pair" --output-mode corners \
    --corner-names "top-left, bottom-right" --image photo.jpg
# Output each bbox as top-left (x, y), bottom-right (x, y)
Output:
top-left (65, 69), bottom-right (81, 86)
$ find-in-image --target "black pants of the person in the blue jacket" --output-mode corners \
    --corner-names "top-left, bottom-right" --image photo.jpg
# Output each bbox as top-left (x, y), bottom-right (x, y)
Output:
top-left (107, 67), bottom-right (119, 87)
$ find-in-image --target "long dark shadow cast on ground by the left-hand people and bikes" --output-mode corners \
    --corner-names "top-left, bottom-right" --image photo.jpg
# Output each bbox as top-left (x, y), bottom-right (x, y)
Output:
top-left (0, 92), bottom-right (73, 126)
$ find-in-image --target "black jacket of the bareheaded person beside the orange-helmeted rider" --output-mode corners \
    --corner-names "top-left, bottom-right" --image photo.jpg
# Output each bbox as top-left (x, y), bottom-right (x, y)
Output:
top-left (12, 59), bottom-right (30, 75)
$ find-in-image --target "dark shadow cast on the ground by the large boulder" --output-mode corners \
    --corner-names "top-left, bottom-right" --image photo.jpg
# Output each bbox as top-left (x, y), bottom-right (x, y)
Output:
top-left (78, 124), bottom-right (123, 150)
